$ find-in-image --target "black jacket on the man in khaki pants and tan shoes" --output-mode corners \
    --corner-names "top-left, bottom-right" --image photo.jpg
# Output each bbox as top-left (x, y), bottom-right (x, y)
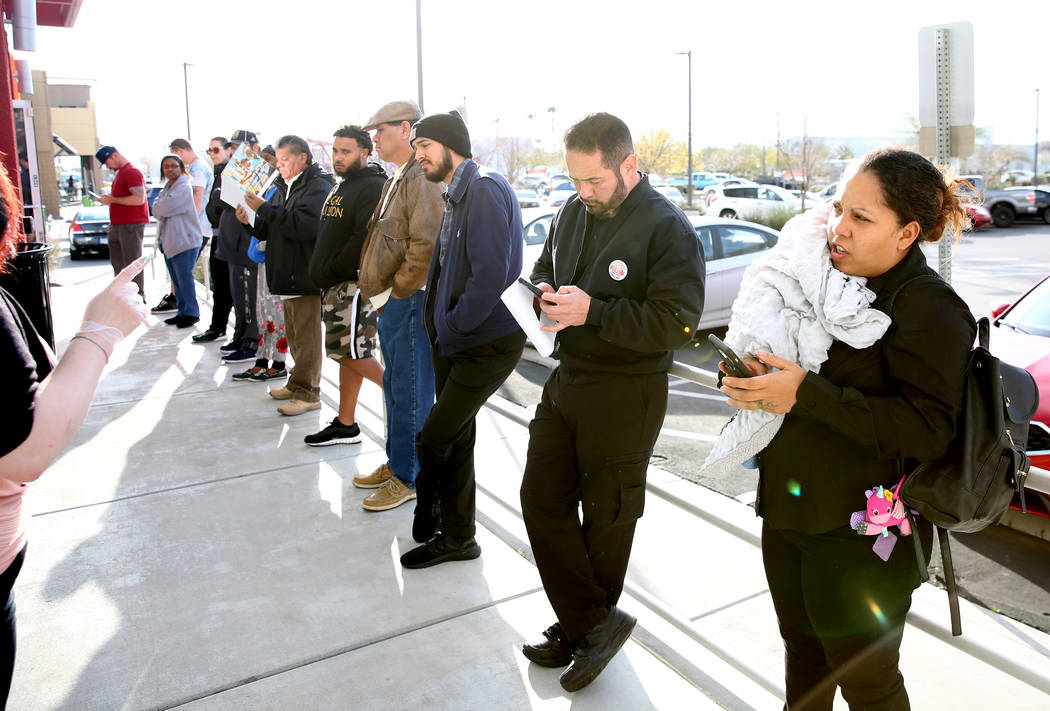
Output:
top-left (248, 163), bottom-right (335, 296)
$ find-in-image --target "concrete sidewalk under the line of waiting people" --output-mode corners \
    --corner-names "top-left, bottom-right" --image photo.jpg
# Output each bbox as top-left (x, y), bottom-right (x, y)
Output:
top-left (8, 263), bottom-right (1050, 710)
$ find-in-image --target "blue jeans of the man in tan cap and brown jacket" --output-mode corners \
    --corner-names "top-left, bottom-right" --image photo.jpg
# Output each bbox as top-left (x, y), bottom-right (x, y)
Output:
top-left (379, 291), bottom-right (434, 488)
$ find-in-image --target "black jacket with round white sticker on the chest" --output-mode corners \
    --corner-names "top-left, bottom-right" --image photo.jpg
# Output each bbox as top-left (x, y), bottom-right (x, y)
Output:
top-left (530, 175), bottom-right (705, 373)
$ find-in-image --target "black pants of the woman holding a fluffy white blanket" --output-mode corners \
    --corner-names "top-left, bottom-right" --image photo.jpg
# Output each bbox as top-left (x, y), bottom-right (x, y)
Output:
top-left (762, 520), bottom-right (932, 711)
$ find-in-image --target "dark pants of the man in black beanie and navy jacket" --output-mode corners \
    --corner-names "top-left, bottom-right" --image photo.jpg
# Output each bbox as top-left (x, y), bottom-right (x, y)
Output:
top-left (416, 331), bottom-right (525, 537)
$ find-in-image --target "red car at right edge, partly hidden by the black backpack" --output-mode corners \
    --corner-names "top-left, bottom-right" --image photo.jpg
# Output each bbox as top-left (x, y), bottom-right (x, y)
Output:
top-left (990, 276), bottom-right (1050, 517)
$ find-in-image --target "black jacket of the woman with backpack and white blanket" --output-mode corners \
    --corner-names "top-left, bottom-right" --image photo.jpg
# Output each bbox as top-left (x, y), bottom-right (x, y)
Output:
top-left (755, 245), bottom-right (977, 534)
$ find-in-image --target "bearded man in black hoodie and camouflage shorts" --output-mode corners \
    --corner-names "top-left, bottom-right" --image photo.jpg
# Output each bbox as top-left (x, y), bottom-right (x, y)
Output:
top-left (305, 126), bottom-right (386, 446)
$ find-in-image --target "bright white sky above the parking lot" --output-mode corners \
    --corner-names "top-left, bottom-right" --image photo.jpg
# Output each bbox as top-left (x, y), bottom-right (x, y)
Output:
top-left (15, 0), bottom-right (1050, 160)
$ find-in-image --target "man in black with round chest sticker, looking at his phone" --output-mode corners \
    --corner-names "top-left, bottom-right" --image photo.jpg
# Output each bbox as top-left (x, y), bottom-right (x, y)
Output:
top-left (521, 113), bottom-right (705, 691)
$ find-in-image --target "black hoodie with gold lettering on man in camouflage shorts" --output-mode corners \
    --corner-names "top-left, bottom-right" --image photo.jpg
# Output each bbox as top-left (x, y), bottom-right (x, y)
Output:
top-left (310, 164), bottom-right (386, 289)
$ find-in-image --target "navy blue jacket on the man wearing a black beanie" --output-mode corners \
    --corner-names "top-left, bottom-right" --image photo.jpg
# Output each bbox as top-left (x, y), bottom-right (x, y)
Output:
top-left (424, 159), bottom-right (522, 355)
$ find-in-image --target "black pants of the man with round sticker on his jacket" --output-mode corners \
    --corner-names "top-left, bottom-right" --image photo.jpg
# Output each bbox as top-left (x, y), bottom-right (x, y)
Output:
top-left (521, 368), bottom-right (667, 640)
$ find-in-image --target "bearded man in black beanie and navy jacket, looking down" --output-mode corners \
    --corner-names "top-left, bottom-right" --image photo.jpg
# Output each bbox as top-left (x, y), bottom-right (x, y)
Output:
top-left (401, 111), bottom-right (525, 568)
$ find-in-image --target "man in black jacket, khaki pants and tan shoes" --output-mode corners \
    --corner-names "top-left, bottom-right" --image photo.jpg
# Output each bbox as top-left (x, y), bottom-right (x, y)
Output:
top-left (236, 135), bottom-right (335, 415)
